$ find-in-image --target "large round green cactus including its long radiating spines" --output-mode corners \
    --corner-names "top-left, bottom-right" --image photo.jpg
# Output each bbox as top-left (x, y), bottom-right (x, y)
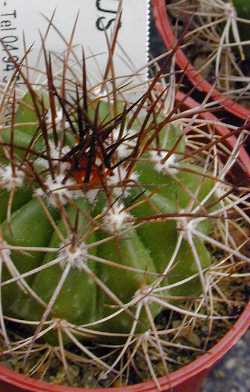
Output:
top-left (0, 34), bottom-right (248, 385)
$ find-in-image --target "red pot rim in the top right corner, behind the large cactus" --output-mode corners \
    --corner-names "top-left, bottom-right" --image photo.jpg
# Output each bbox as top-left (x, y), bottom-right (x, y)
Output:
top-left (152, 0), bottom-right (250, 122)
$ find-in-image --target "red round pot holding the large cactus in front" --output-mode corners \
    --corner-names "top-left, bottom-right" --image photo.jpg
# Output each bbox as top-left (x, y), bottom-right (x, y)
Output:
top-left (0, 92), bottom-right (250, 392)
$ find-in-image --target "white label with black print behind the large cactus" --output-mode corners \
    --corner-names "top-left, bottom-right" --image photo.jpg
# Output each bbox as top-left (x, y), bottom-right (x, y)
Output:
top-left (0, 0), bottom-right (150, 89)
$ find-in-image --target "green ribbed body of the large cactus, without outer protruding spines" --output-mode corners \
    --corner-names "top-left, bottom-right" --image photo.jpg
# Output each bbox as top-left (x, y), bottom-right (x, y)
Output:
top-left (0, 86), bottom-right (213, 339)
